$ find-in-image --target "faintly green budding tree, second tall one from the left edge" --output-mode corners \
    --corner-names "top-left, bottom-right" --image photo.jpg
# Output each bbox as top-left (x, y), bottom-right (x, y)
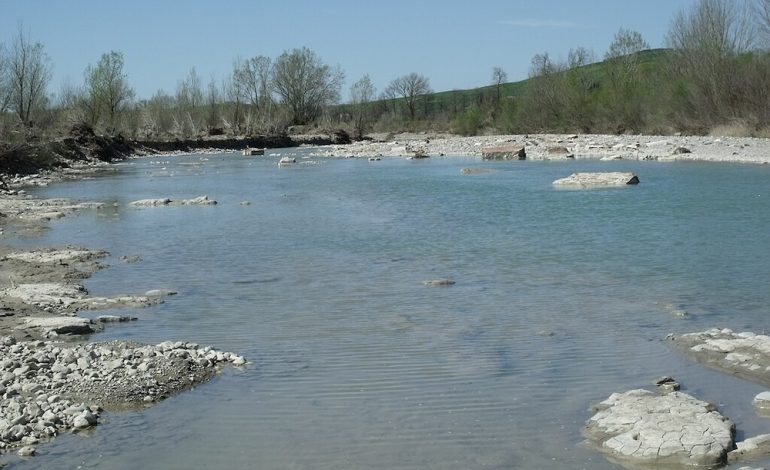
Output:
top-left (86, 51), bottom-right (134, 129)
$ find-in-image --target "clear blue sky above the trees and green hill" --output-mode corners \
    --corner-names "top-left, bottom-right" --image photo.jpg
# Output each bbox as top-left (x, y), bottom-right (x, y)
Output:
top-left (0, 0), bottom-right (695, 100)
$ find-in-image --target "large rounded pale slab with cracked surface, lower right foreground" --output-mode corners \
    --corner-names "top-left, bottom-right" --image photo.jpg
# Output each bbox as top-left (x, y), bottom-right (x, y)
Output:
top-left (584, 390), bottom-right (735, 466)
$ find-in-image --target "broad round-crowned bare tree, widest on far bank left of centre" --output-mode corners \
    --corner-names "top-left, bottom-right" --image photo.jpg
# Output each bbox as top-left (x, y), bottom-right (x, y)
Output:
top-left (272, 47), bottom-right (345, 124)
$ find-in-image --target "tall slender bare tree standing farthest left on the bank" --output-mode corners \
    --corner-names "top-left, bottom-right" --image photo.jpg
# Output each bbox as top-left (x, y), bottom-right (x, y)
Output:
top-left (8, 26), bottom-right (52, 126)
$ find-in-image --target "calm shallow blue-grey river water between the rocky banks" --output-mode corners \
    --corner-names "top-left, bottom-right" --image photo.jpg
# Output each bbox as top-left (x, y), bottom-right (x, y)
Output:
top-left (4, 150), bottom-right (770, 469)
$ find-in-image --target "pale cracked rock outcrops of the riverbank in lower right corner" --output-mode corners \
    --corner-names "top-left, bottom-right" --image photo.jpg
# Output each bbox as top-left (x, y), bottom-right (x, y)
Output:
top-left (583, 328), bottom-right (770, 468)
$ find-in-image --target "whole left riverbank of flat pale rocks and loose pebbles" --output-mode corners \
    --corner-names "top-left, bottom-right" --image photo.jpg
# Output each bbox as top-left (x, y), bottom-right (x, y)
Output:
top-left (0, 185), bottom-right (246, 466)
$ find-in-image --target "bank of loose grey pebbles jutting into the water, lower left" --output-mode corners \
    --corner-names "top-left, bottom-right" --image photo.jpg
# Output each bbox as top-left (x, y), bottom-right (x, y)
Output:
top-left (0, 337), bottom-right (247, 457)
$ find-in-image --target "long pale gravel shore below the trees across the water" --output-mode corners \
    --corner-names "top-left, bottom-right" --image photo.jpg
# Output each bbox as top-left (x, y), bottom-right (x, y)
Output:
top-left (308, 134), bottom-right (770, 164)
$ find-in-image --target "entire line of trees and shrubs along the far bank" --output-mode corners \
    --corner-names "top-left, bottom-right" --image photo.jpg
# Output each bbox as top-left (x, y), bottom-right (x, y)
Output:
top-left (0, 0), bottom-right (770, 139)
